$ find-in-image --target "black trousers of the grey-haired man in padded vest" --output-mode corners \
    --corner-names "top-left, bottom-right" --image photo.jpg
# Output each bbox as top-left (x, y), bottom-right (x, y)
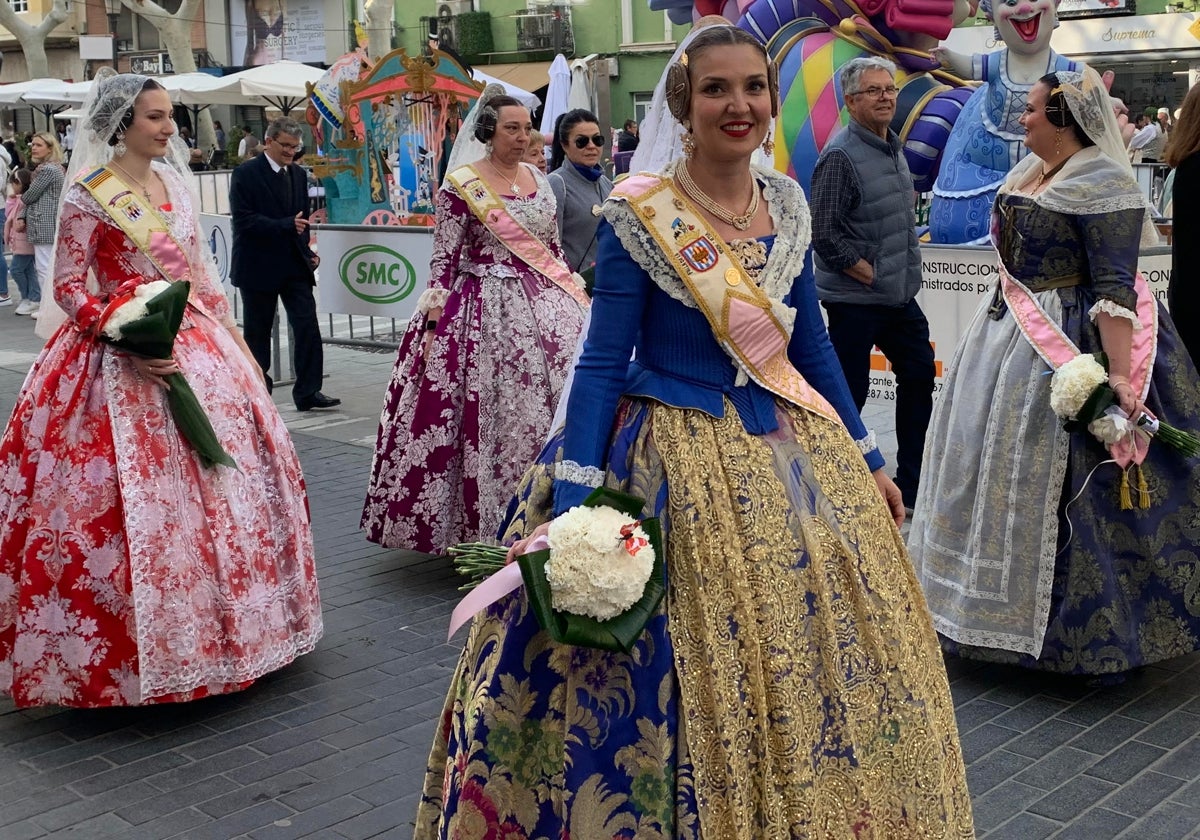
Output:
top-left (823, 300), bottom-right (935, 506)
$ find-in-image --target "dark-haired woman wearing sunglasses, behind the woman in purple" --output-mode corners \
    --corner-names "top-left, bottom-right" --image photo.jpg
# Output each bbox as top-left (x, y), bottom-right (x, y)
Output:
top-left (547, 108), bottom-right (612, 278)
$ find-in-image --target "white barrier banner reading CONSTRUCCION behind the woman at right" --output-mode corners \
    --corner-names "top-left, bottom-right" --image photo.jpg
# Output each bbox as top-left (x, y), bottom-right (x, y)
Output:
top-left (868, 245), bottom-right (1171, 404)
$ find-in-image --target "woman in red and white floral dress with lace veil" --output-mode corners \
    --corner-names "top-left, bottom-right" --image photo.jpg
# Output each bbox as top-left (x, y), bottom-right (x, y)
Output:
top-left (0, 76), bottom-right (322, 707)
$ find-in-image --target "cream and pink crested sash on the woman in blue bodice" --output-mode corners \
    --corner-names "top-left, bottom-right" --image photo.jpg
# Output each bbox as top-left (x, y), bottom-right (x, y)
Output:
top-left (612, 174), bottom-right (841, 425)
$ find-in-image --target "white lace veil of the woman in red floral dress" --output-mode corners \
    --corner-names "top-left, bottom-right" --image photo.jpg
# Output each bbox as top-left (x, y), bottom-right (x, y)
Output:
top-left (35, 67), bottom-right (221, 338)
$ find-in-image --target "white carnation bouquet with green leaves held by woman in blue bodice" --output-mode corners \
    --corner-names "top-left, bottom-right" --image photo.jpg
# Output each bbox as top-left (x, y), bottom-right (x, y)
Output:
top-left (449, 487), bottom-right (666, 653)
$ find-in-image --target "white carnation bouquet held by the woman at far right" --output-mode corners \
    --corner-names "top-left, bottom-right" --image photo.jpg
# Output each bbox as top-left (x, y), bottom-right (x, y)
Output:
top-left (1050, 353), bottom-right (1200, 457)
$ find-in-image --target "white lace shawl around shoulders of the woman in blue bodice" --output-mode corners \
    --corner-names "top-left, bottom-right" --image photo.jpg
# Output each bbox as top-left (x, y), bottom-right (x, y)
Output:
top-left (604, 162), bottom-right (812, 336)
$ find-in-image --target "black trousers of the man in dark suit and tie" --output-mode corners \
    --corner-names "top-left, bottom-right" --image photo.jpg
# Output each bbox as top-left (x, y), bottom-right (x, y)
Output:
top-left (239, 277), bottom-right (325, 401)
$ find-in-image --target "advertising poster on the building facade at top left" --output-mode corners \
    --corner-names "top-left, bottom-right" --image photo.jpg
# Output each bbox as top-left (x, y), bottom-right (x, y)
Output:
top-left (229, 0), bottom-right (325, 67)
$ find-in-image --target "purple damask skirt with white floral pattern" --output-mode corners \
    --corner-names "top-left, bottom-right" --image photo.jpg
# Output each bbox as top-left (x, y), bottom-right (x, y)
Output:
top-left (361, 270), bottom-right (584, 554)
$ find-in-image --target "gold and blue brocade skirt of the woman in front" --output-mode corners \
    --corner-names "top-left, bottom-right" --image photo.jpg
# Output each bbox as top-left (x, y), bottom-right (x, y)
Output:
top-left (416, 400), bottom-right (974, 840)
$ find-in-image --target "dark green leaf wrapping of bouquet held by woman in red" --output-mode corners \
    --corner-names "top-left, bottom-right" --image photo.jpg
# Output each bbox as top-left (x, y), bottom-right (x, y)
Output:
top-left (104, 280), bottom-right (238, 468)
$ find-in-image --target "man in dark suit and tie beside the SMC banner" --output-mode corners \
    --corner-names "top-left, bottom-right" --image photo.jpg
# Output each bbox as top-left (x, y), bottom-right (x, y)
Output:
top-left (229, 116), bottom-right (342, 412)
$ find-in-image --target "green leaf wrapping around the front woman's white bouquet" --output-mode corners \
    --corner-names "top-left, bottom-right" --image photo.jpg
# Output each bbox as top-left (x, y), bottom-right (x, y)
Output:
top-left (517, 487), bottom-right (666, 653)
